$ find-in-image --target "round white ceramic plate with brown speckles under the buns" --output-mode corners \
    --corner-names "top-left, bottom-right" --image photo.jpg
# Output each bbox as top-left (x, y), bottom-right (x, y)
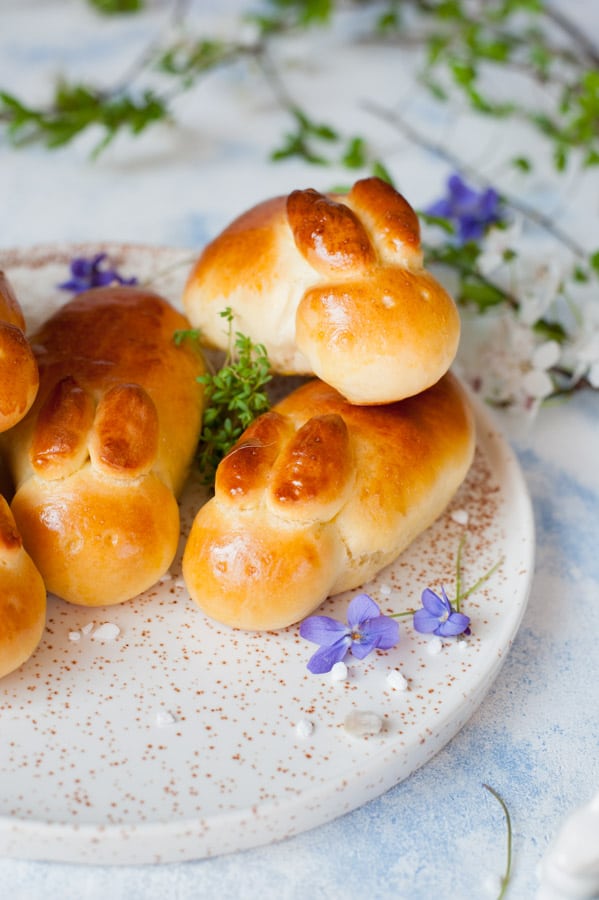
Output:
top-left (0, 245), bottom-right (534, 864)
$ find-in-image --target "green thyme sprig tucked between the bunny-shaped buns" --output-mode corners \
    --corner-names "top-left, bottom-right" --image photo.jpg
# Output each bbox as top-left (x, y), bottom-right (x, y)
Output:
top-left (175, 307), bottom-right (272, 485)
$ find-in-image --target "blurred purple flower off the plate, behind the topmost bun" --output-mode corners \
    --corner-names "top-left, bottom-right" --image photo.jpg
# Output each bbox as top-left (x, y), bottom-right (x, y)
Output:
top-left (426, 175), bottom-right (502, 244)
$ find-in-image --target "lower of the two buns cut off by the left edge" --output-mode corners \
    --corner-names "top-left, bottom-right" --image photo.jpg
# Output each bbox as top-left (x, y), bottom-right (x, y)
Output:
top-left (0, 496), bottom-right (46, 678)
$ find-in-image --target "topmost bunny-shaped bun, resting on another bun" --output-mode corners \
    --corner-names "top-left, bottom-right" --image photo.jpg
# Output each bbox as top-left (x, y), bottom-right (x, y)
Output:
top-left (183, 178), bottom-right (460, 404)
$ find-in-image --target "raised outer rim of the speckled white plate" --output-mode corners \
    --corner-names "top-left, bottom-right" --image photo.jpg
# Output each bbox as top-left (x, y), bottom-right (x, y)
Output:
top-left (0, 243), bottom-right (534, 865)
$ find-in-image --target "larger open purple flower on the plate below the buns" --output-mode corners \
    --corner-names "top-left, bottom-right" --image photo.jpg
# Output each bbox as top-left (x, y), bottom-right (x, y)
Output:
top-left (300, 594), bottom-right (399, 675)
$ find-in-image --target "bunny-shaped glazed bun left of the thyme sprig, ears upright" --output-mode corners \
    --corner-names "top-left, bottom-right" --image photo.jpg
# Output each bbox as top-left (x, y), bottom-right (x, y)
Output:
top-left (5, 286), bottom-right (204, 606)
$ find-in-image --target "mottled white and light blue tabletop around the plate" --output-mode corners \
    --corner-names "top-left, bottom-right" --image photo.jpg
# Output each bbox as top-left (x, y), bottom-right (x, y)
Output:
top-left (0, 0), bottom-right (599, 900)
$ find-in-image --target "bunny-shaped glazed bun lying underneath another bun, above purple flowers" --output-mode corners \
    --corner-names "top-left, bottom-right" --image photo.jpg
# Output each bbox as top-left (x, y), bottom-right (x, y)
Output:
top-left (183, 374), bottom-right (475, 630)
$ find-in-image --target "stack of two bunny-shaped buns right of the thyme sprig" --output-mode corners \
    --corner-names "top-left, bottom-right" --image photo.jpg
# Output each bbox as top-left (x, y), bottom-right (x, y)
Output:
top-left (183, 178), bottom-right (475, 629)
